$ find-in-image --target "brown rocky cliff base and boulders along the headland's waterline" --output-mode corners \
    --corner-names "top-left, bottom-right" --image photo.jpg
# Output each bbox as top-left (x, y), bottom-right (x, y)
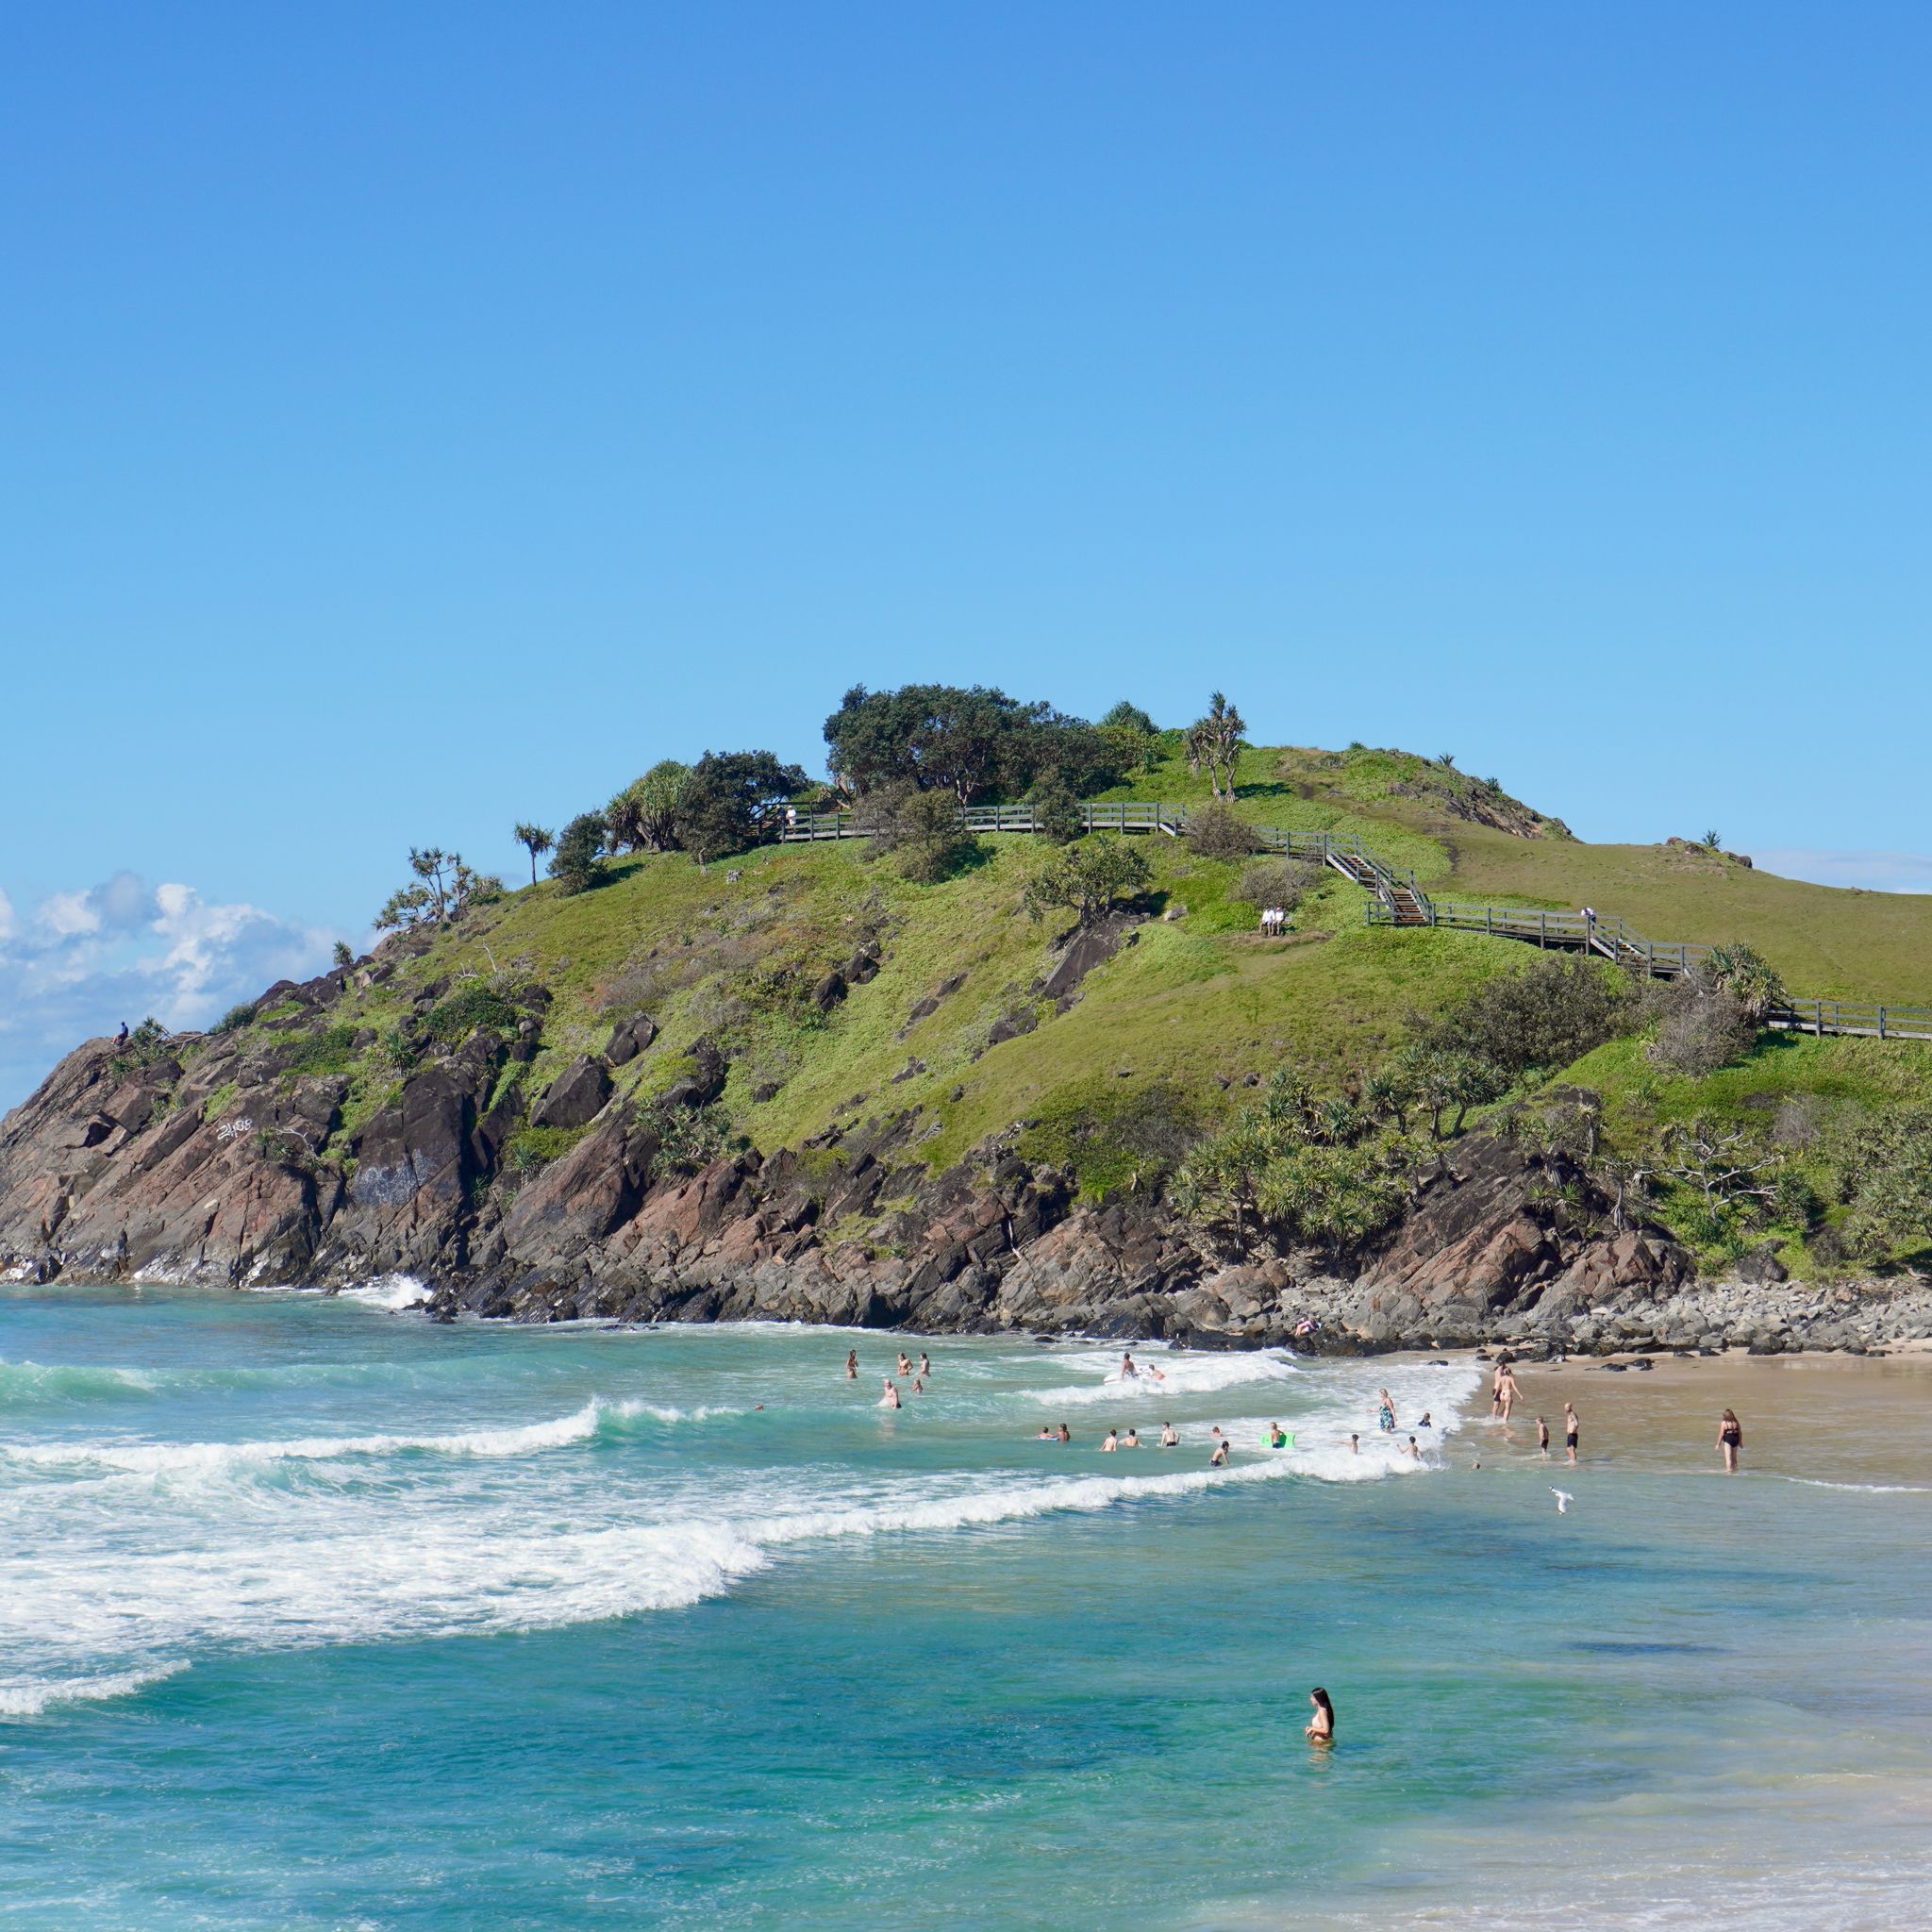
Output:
top-left (0, 1012), bottom-right (1932, 1353)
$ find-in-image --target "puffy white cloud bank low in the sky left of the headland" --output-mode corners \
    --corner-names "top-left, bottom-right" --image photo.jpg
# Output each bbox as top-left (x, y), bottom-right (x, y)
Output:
top-left (0, 872), bottom-right (336, 1108)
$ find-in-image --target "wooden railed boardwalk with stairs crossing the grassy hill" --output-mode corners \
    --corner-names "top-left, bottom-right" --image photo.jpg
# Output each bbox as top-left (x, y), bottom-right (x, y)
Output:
top-left (765, 800), bottom-right (1932, 1040)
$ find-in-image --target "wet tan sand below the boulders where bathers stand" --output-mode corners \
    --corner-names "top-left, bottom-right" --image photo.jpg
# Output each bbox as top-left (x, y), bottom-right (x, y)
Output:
top-left (1437, 1349), bottom-right (1932, 1488)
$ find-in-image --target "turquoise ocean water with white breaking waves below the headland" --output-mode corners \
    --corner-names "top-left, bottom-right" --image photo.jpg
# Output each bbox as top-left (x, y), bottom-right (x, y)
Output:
top-left (0, 1287), bottom-right (1932, 1932)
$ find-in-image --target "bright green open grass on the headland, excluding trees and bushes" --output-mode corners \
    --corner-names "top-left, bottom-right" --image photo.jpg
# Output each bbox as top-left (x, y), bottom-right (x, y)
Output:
top-left (192, 730), bottom-right (1932, 1259)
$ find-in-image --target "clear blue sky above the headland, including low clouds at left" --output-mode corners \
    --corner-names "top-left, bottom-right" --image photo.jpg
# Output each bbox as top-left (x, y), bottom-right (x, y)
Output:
top-left (0, 0), bottom-right (1932, 1101)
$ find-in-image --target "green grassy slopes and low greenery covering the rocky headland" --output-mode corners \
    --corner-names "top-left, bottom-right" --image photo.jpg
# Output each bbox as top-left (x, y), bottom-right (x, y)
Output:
top-left (188, 732), bottom-right (1932, 1274)
